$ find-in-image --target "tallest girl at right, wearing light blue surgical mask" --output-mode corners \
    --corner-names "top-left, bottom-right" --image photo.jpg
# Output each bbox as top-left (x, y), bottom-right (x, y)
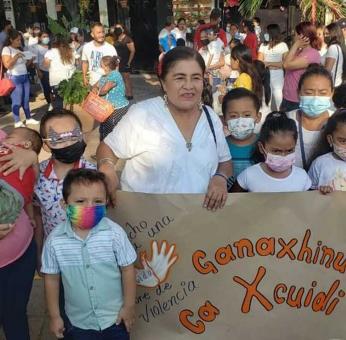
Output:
top-left (288, 65), bottom-right (333, 170)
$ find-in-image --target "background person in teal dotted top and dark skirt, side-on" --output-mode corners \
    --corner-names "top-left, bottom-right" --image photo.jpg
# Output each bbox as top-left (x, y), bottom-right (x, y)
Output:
top-left (92, 56), bottom-right (129, 141)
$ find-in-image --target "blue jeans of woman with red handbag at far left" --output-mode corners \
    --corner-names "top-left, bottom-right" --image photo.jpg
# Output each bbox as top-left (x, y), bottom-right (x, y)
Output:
top-left (11, 74), bottom-right (31, 122)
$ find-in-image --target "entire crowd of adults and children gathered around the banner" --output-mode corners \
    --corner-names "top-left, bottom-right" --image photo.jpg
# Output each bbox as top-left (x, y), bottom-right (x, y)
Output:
top-left (0, 9), bottom-right (346, 340)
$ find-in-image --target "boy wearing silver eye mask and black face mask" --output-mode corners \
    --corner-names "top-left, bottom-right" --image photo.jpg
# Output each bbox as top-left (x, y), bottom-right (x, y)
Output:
top-left (34, 109), bottom-right (95, 266)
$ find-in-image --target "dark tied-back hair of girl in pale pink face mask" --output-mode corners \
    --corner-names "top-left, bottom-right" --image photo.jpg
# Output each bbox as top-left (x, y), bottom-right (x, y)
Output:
top-left (253, 111), bottom-right (298, 163)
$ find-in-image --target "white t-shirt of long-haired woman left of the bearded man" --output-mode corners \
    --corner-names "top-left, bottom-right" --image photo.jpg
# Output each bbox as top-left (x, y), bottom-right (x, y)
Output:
top-left (44, 48), bottom-right (76, 86)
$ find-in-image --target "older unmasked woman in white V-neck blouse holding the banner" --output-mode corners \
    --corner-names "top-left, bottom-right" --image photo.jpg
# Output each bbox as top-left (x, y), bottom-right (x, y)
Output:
top-left (97, 47), bottom-right (232, 210)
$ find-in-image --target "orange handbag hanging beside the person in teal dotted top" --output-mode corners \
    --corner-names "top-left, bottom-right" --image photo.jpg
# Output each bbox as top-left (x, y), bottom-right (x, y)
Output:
top-left (82, 92), bottom-right (115, 123)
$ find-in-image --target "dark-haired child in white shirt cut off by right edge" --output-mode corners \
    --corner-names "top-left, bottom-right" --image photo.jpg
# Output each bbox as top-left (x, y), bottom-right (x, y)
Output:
top-left (309, 109), bottom-right (346, 194)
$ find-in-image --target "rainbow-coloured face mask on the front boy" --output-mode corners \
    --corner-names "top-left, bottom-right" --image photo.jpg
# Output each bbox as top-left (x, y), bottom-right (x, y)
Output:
top-left (66, 204), bottom-right (106, 229)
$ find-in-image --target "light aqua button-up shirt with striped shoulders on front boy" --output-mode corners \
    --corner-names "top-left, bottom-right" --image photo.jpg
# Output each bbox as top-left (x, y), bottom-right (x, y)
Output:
top-left (42, 217), bottom-right (137, 330)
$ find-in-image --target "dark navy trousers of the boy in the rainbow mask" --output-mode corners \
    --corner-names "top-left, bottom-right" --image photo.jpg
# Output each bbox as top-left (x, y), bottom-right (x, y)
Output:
top-left (70, 323), bottom-right (130, 340)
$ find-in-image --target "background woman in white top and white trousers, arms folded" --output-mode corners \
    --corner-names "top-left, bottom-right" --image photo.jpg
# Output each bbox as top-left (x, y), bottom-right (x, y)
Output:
top-left (258, 24), bottom-right (288, 110)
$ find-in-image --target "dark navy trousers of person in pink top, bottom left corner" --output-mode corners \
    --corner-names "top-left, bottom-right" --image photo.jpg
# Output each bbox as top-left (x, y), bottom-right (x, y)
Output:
top-left (0, 241), bottom-right (36, 340)
